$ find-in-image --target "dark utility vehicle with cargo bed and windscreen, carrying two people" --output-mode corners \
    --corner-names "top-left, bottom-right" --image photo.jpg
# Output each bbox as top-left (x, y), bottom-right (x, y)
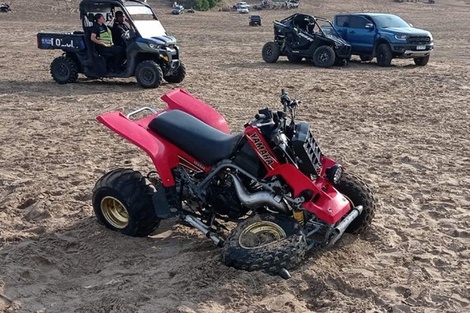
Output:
top-left (37, 0), bottom-right (186, 88)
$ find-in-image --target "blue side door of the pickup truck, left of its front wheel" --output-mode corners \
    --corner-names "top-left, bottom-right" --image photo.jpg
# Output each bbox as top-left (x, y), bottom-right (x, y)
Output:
top-left (346, 15), bottom-right (376, 55)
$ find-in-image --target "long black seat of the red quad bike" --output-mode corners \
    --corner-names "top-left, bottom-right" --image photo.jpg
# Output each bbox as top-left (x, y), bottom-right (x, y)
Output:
top-left (148, 110), bottom-right (243, 165)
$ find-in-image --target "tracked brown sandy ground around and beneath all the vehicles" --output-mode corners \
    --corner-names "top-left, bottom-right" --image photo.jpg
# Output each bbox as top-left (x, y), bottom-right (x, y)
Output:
top-left (0, 0), bottom-right (470, 313)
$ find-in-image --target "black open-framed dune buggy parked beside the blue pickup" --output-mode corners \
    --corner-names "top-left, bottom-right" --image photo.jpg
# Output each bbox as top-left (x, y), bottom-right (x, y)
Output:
top-left (262, 13), bottom-right (351, 67)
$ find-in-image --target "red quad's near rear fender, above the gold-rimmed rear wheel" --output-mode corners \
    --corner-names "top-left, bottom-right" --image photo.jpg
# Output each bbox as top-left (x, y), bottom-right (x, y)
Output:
top-left (97, 112), bottom-right (178, 187)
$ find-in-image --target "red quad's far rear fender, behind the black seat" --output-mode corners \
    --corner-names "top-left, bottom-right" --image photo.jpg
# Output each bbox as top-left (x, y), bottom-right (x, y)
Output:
top-left (161, 88), bottom-right (230, 134)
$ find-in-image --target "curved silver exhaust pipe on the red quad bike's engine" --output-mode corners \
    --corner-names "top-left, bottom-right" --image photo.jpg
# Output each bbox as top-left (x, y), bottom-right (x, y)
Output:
top-left (230, 174), bottom-right (288, 212)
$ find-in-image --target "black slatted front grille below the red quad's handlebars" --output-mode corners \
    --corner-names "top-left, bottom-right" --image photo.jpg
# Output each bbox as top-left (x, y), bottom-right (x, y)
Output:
top-left (292, 122), bottom-right (322, 175)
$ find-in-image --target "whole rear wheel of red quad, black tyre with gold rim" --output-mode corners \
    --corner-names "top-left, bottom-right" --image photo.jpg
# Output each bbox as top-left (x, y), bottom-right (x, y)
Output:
top-left (92, 169), bottom-right (160, 237)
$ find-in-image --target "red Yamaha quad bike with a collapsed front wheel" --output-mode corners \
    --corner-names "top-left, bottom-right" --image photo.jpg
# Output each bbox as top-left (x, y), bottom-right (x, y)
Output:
top-left (92, 89), bottom-right (376, 278)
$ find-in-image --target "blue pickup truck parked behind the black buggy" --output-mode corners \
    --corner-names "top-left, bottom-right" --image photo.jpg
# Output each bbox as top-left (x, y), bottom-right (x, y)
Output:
top-left (334, 13), bottom-right (434, 66)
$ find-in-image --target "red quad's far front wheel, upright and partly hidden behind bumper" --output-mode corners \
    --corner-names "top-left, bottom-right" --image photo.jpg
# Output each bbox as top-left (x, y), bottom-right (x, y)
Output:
top-left (335, 172), bottom-right (376, 234)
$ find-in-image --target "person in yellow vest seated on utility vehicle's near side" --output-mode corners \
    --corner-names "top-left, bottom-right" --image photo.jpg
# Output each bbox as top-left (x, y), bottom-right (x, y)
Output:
top-left (91, 13), bottom-right (125, 72)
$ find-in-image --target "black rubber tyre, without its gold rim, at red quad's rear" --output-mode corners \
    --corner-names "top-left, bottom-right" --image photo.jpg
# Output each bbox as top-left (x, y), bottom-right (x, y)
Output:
top-left (92, 168), bottom-right (160, 237)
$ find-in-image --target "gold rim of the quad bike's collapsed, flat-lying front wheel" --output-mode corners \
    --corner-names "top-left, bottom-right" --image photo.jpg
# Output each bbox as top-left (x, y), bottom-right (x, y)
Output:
top-left (238, 221), bottom-right (287, 249)
